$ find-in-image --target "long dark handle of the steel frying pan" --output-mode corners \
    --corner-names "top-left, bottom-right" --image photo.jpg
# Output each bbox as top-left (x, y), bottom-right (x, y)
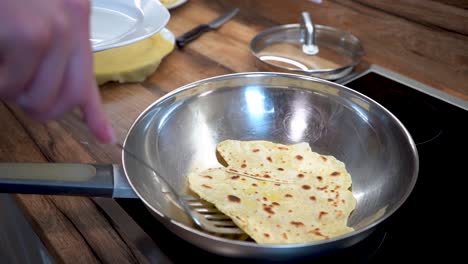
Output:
top-left (0, 163), bottom-right (136, 198)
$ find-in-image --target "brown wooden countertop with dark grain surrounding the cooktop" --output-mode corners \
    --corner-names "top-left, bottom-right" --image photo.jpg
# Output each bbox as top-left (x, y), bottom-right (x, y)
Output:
top-left (0, 0), bottom-right (468, 263)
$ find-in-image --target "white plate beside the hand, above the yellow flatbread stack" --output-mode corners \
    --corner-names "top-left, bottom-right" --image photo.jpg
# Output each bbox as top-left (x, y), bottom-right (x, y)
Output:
top-left (90, 0), bottom-right (170, 52)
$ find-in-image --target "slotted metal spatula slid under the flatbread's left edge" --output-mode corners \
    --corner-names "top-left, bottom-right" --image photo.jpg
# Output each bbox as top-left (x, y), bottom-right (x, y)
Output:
top-left (116, 143), bottom-right (244, 235)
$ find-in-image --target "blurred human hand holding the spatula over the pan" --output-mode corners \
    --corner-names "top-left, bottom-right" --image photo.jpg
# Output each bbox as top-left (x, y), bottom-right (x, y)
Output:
top-left (0, 0), bottom-right (115, 142)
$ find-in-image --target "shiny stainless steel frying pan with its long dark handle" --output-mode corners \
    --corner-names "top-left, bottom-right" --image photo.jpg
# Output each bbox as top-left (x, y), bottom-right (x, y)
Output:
top-left (0, 73), bottom-right (418, 260)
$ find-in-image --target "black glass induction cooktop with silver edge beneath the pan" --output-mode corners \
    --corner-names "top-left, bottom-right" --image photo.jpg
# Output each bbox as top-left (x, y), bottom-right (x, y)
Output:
top-left (117, 66), bottom-right (468, 263)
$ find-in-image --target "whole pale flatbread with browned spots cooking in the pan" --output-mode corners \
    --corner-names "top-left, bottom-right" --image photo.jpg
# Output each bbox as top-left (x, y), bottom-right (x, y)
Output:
top-left (188, 140), bottom-right (356, 244)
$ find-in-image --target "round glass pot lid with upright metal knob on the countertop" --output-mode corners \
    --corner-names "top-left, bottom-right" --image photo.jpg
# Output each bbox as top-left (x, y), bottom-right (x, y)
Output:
top-left (250, 12), bottom-right (363, 80)
